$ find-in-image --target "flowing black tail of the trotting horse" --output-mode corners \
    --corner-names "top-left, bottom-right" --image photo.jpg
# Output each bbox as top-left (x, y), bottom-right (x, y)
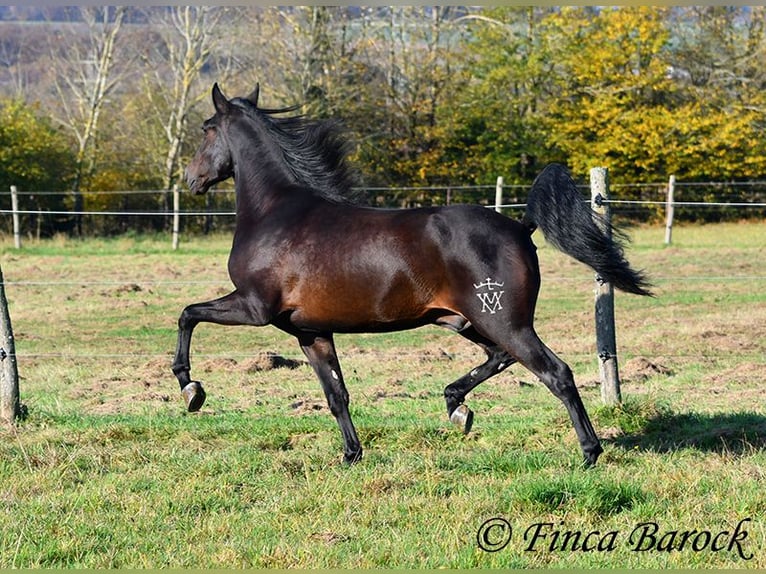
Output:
top-left (522, 163), bottom-right (652, 295)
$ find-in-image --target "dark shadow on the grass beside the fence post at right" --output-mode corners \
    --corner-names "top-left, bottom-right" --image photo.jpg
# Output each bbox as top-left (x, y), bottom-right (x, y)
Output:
top-left (605, 410), bottom-right (766, 455)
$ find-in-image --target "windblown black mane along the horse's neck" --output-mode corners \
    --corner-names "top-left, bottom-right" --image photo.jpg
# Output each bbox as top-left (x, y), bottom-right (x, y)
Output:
top-left (231, 98), bottom-right (362, 204)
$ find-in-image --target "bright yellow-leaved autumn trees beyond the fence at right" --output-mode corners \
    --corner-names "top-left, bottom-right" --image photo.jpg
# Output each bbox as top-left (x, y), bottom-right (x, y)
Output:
top-left (545, 6), bottom-right (766, 181)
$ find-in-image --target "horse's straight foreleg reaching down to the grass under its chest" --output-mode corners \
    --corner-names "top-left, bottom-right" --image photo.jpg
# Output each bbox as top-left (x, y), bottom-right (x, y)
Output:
top-left (298, 334), bottom-right (362, 464)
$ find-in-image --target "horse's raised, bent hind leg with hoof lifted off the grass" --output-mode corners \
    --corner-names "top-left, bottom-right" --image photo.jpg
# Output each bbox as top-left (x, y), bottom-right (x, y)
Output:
top-left (444, 326), bottom-right (516, 434)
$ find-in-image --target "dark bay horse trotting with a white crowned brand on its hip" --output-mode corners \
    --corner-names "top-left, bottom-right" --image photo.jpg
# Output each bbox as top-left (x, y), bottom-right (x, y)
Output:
top-left (173, 84), bottom-right (649, 464)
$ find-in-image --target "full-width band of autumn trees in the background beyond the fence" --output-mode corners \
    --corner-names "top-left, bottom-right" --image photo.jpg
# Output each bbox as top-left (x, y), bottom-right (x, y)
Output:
top-left (0, 6), bottom-right (766, 235)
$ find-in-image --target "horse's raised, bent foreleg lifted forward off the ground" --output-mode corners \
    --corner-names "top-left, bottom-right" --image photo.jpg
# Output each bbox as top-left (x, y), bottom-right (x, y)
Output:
top-left (172, 291), bottom-right (265, 412)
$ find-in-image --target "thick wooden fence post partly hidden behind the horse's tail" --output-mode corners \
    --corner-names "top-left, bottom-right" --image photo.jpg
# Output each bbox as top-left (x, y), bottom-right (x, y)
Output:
top-left (590, 167), bottom-right (622, 405)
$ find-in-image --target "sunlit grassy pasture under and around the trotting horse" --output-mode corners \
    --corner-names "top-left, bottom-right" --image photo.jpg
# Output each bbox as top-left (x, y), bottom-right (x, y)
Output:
top-left (0, 223), bottom-right (766, 568)
